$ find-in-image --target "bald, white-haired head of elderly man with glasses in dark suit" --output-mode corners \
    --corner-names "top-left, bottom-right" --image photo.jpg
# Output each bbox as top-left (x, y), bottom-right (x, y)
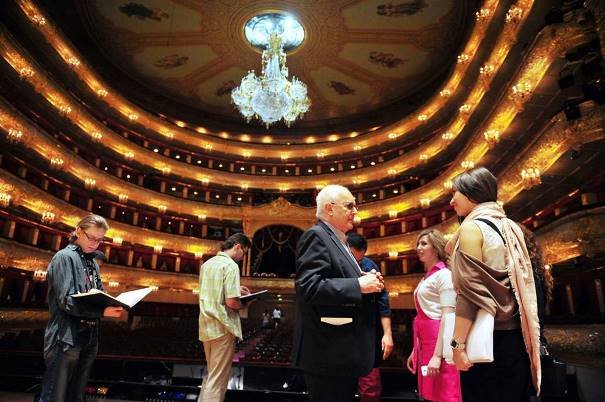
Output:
top-left (315, 184), bottom-right (357, 233)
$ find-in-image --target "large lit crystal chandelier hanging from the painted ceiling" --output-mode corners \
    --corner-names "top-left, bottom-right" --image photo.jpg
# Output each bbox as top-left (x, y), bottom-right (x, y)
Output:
top-left (231, 32), bottom-right (311, 128)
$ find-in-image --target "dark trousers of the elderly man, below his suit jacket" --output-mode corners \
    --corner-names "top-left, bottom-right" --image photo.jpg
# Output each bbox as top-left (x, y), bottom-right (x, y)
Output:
top-left (305, 371), bottom-right (357, 402)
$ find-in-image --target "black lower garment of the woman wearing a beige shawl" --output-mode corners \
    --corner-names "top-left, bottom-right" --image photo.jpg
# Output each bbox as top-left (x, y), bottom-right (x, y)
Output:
top-left (460, 329), bottom-right (533, 402)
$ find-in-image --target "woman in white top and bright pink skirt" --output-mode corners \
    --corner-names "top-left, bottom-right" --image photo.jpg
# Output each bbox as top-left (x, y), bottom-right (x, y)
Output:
top-left (407, 229), bottom-right (462, 402)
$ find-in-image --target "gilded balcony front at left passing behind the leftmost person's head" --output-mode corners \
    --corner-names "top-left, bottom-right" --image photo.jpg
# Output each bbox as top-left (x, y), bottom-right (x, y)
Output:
top-left (0, 169), bottom-right (219, 254)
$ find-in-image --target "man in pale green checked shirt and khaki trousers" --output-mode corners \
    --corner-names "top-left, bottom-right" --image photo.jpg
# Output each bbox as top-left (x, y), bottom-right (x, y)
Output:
top-left (198, 233), bottom-right (251, 402)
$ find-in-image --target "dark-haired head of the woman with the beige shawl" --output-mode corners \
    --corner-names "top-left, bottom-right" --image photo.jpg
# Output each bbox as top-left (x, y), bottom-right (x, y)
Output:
top-left (450, 167), bottom-right (498, 216)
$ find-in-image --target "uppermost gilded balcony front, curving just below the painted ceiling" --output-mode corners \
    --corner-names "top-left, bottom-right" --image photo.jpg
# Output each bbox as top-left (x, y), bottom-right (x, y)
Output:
top-left (14, 0), bottom-right (520, 153)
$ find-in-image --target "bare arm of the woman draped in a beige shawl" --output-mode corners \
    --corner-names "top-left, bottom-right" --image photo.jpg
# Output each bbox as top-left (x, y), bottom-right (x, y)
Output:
top-left (453, 222), bottom-right (483, 371)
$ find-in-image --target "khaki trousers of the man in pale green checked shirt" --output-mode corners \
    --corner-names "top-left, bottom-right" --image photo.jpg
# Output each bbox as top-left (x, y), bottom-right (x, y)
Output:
top-left (198, 333), bottom-right (235, 402)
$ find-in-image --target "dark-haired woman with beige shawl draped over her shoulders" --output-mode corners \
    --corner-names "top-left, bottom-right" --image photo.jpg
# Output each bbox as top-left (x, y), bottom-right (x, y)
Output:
top-left (448, 167), bottom-right (541, 402)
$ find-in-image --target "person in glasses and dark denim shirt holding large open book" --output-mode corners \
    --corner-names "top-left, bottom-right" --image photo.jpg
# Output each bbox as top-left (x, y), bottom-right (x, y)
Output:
top-left (40, 215), bottom-right (123, 402)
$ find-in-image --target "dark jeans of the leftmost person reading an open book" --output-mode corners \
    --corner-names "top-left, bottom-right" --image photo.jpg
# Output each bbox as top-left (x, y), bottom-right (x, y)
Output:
top-left (39, 327), bottom-right (98, 402)
